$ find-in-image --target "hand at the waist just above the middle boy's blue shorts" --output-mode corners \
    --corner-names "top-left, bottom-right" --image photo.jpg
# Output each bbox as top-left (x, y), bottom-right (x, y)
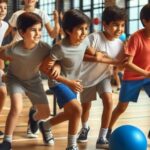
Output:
top-left (68, 80), bottom-right (83, 93)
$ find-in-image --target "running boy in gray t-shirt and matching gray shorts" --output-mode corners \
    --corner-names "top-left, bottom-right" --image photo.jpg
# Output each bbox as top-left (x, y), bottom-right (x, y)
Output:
top-left (0, 12), bottom-right (58, 150)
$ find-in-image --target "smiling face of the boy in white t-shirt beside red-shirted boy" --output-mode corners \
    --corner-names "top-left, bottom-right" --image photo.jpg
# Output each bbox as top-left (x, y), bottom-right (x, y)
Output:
top-left (103, 20), bottom-right (125, 39)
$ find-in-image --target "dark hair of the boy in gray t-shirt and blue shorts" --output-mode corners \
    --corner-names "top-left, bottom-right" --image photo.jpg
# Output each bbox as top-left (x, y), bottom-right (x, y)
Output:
top-left (62, 9), bottom-right (91, 34)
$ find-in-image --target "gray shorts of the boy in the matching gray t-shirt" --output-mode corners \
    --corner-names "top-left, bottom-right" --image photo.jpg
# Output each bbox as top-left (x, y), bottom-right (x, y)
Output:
top-left (7, 75), bottom-right (48, 105)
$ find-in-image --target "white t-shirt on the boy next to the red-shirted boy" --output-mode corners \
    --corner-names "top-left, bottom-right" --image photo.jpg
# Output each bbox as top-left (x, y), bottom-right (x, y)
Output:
top-left (80, 32), bottom-right (123, 87)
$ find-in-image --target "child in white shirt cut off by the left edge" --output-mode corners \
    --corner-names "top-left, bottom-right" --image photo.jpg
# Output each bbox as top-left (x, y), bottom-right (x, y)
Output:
top-left (0, 0), bottom-right (8, 138)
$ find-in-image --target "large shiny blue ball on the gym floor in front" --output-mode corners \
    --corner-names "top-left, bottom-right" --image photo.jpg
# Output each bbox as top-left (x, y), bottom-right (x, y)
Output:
top-left (109, 125), bottom-right (147, 150)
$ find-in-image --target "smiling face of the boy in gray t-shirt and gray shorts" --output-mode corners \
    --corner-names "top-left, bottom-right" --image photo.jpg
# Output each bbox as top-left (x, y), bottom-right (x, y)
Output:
top-left (21, 23), bottom-right (42, 46)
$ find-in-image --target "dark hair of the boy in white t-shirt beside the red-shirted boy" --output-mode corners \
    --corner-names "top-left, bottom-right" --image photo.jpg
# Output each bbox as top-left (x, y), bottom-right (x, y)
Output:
top-left (102, 6), bottom-right (127, 24)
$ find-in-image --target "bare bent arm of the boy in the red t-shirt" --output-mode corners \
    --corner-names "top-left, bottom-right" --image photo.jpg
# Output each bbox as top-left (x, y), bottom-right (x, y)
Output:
top-left (124, 55), bottom-right (150, 78)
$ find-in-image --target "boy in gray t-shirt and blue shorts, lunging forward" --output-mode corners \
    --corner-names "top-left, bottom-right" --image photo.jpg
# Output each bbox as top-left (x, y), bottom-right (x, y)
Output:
top-left (39, 9), bottom-right (121, 150)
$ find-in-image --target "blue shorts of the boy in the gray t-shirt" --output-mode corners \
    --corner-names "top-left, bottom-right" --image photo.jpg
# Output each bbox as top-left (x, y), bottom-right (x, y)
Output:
top-left (50, 84), bottom-right (77, 108)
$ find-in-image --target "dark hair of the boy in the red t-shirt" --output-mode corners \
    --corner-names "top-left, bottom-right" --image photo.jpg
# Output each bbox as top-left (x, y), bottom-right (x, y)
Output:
top-left (140, 4), bottom-right (150, 26)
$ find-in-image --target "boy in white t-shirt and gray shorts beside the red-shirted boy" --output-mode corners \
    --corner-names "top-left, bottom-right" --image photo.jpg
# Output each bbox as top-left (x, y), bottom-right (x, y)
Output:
top-left (77, 6), bottom-right (126, 148)
